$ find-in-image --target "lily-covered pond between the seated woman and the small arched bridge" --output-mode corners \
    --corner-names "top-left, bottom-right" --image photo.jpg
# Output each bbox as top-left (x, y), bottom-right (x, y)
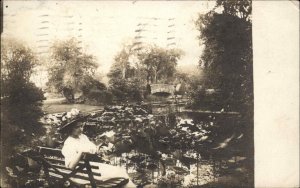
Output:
top-left (38, 105), bottom-right (251, 187)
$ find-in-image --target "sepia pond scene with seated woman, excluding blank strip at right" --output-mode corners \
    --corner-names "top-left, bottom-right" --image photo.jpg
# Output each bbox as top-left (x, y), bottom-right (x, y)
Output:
top-left (1, 0), bottom-right (296, 188)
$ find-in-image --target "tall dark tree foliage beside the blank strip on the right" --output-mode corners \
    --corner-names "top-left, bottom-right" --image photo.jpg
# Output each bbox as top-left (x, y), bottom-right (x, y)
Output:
top-left (196, 1), bottom-right (253, 111)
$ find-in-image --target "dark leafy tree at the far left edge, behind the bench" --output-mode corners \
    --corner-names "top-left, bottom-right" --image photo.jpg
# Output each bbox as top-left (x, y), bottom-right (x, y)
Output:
top-left (1, 39), bottom-right (45, 158)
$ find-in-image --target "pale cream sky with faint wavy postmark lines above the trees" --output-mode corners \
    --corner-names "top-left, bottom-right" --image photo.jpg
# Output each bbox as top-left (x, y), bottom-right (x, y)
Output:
top-left (2, 1), bottom-right (215, 82)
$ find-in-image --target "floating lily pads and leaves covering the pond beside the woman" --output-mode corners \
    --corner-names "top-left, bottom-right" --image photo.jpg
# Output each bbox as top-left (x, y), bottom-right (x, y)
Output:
top-left (80, 105), bottom-right (243, 187)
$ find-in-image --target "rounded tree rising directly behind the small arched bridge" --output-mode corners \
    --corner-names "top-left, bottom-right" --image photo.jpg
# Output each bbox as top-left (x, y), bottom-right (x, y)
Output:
top-left (139, 46), bottom-right (183, 84)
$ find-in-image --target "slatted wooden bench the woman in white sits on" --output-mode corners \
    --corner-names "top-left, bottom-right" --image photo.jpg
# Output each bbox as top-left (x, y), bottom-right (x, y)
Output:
top-left (31, 147), bottom-right (129, 188)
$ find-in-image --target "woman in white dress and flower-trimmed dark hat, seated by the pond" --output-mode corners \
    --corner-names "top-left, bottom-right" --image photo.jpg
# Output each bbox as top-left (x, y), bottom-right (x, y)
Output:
top-left (59, 120), bottom-right (136, 188)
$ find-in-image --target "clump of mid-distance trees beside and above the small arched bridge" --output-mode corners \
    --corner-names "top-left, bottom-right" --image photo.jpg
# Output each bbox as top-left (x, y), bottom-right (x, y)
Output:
top-left (108, 44), bottom-right (183, 101)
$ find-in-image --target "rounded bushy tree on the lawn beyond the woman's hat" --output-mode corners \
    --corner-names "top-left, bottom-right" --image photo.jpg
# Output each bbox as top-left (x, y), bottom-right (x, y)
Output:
top-left (48, 38), bottom-right (97, 102)
